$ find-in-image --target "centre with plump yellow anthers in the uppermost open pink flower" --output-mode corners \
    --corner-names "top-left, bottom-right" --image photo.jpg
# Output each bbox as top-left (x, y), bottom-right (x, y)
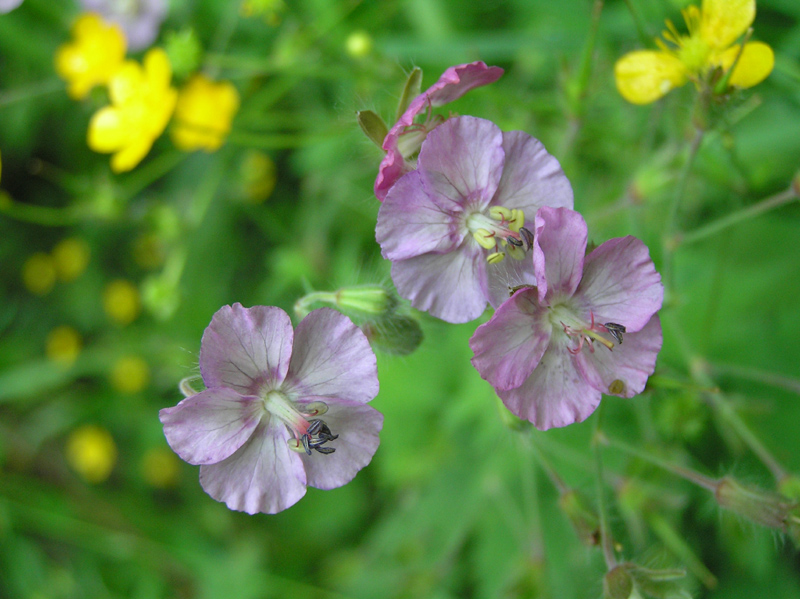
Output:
top-left (465, 206), bottom-right (533, 264)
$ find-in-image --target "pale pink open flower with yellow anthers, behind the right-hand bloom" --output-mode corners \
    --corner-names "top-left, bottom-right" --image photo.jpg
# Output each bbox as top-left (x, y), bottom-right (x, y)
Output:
top-left (375, 116), bottom-right (572, 322)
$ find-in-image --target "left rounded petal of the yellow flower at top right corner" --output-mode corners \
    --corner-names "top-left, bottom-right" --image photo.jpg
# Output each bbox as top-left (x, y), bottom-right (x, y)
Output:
top-left (614, 50), bottom-right (687, 104)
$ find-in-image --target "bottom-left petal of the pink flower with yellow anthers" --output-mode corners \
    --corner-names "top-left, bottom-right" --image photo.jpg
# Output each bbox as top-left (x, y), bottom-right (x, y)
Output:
top-left (392, 238), bottom-right (488, 323)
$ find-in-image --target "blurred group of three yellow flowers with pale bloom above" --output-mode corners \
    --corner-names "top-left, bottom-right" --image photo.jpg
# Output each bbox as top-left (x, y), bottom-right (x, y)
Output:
top-left (55, 10), bottom-right (239, 173)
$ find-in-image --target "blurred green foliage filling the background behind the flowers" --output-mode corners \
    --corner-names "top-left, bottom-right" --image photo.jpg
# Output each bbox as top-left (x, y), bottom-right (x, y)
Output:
top-left (0, 0), bottom-right (800, 599)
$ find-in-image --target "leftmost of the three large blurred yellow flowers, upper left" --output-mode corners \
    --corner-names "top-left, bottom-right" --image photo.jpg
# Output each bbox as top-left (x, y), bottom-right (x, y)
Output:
top-left (55, 13), bottom-right (125, 100)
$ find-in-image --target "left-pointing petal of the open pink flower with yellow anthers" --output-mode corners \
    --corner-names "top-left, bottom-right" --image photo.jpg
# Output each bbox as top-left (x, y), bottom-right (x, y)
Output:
top-left (375, 171), bottom-right (464, 260)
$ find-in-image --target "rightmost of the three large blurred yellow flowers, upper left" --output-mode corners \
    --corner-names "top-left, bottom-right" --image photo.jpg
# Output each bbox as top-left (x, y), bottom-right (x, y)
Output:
top-left (171, 73), bottom-right (239, 152)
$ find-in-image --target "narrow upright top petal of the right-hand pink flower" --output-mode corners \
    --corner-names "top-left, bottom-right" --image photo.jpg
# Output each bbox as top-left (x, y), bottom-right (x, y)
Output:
top-left (533, 206), bottom-right (587, 305)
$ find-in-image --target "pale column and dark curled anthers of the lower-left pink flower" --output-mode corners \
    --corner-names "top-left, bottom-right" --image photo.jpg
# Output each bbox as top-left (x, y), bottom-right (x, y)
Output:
top-left (264, 391), bottom-right (339, 455)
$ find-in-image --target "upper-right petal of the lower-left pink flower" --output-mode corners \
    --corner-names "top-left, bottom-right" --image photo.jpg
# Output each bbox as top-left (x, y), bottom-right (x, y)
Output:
top-left (285, 308), bottom-right (378, 403)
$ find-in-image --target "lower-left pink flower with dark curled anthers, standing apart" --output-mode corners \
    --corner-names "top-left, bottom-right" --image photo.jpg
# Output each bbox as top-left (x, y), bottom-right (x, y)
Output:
top-left (159, 304), bottom-right (383, 514)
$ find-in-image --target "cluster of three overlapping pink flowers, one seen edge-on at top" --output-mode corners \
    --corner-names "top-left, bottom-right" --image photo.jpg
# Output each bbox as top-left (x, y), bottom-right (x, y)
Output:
top-left (375, 63), bottom-right (663, 429)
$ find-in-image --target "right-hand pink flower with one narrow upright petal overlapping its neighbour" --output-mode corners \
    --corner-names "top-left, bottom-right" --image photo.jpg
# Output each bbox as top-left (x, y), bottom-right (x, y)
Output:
top-left (470, 208), bottom-right (664, 430)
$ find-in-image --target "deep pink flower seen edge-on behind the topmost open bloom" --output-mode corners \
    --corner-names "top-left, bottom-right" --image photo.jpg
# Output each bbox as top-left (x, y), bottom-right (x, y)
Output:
top-left (375, 61), bottom-right (503, 202)
